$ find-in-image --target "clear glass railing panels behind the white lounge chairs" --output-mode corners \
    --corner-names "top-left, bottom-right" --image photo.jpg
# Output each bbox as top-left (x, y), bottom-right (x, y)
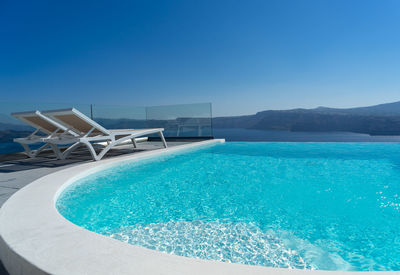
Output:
top-left (0, 102), bottom-right (213, 154)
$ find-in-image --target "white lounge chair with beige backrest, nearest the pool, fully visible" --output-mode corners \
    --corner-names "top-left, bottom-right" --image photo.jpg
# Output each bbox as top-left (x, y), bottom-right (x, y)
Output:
top-left (43, 108), bottom-right (167, 161)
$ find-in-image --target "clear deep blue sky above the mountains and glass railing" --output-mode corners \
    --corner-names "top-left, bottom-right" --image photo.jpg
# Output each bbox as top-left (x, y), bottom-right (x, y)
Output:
top-left (0, 0), bottom-right (400, 115)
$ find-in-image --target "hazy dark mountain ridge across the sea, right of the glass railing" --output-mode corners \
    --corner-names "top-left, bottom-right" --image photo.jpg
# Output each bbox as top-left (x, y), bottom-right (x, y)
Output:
top-left (213, 101), bottom-right (400, 135)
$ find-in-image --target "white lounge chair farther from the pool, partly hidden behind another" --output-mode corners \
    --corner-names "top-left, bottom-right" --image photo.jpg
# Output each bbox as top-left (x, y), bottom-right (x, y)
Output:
top-left (11, 111), bottom-right (77, 158)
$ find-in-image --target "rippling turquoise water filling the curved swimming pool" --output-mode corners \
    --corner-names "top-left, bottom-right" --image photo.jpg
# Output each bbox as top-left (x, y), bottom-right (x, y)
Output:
top-left (56, 142), bottom-right (400, 271)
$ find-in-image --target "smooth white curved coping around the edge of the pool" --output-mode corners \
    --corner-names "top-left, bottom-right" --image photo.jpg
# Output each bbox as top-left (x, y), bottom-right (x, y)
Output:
top-left (0, 139), bottom-right (399, 275)
